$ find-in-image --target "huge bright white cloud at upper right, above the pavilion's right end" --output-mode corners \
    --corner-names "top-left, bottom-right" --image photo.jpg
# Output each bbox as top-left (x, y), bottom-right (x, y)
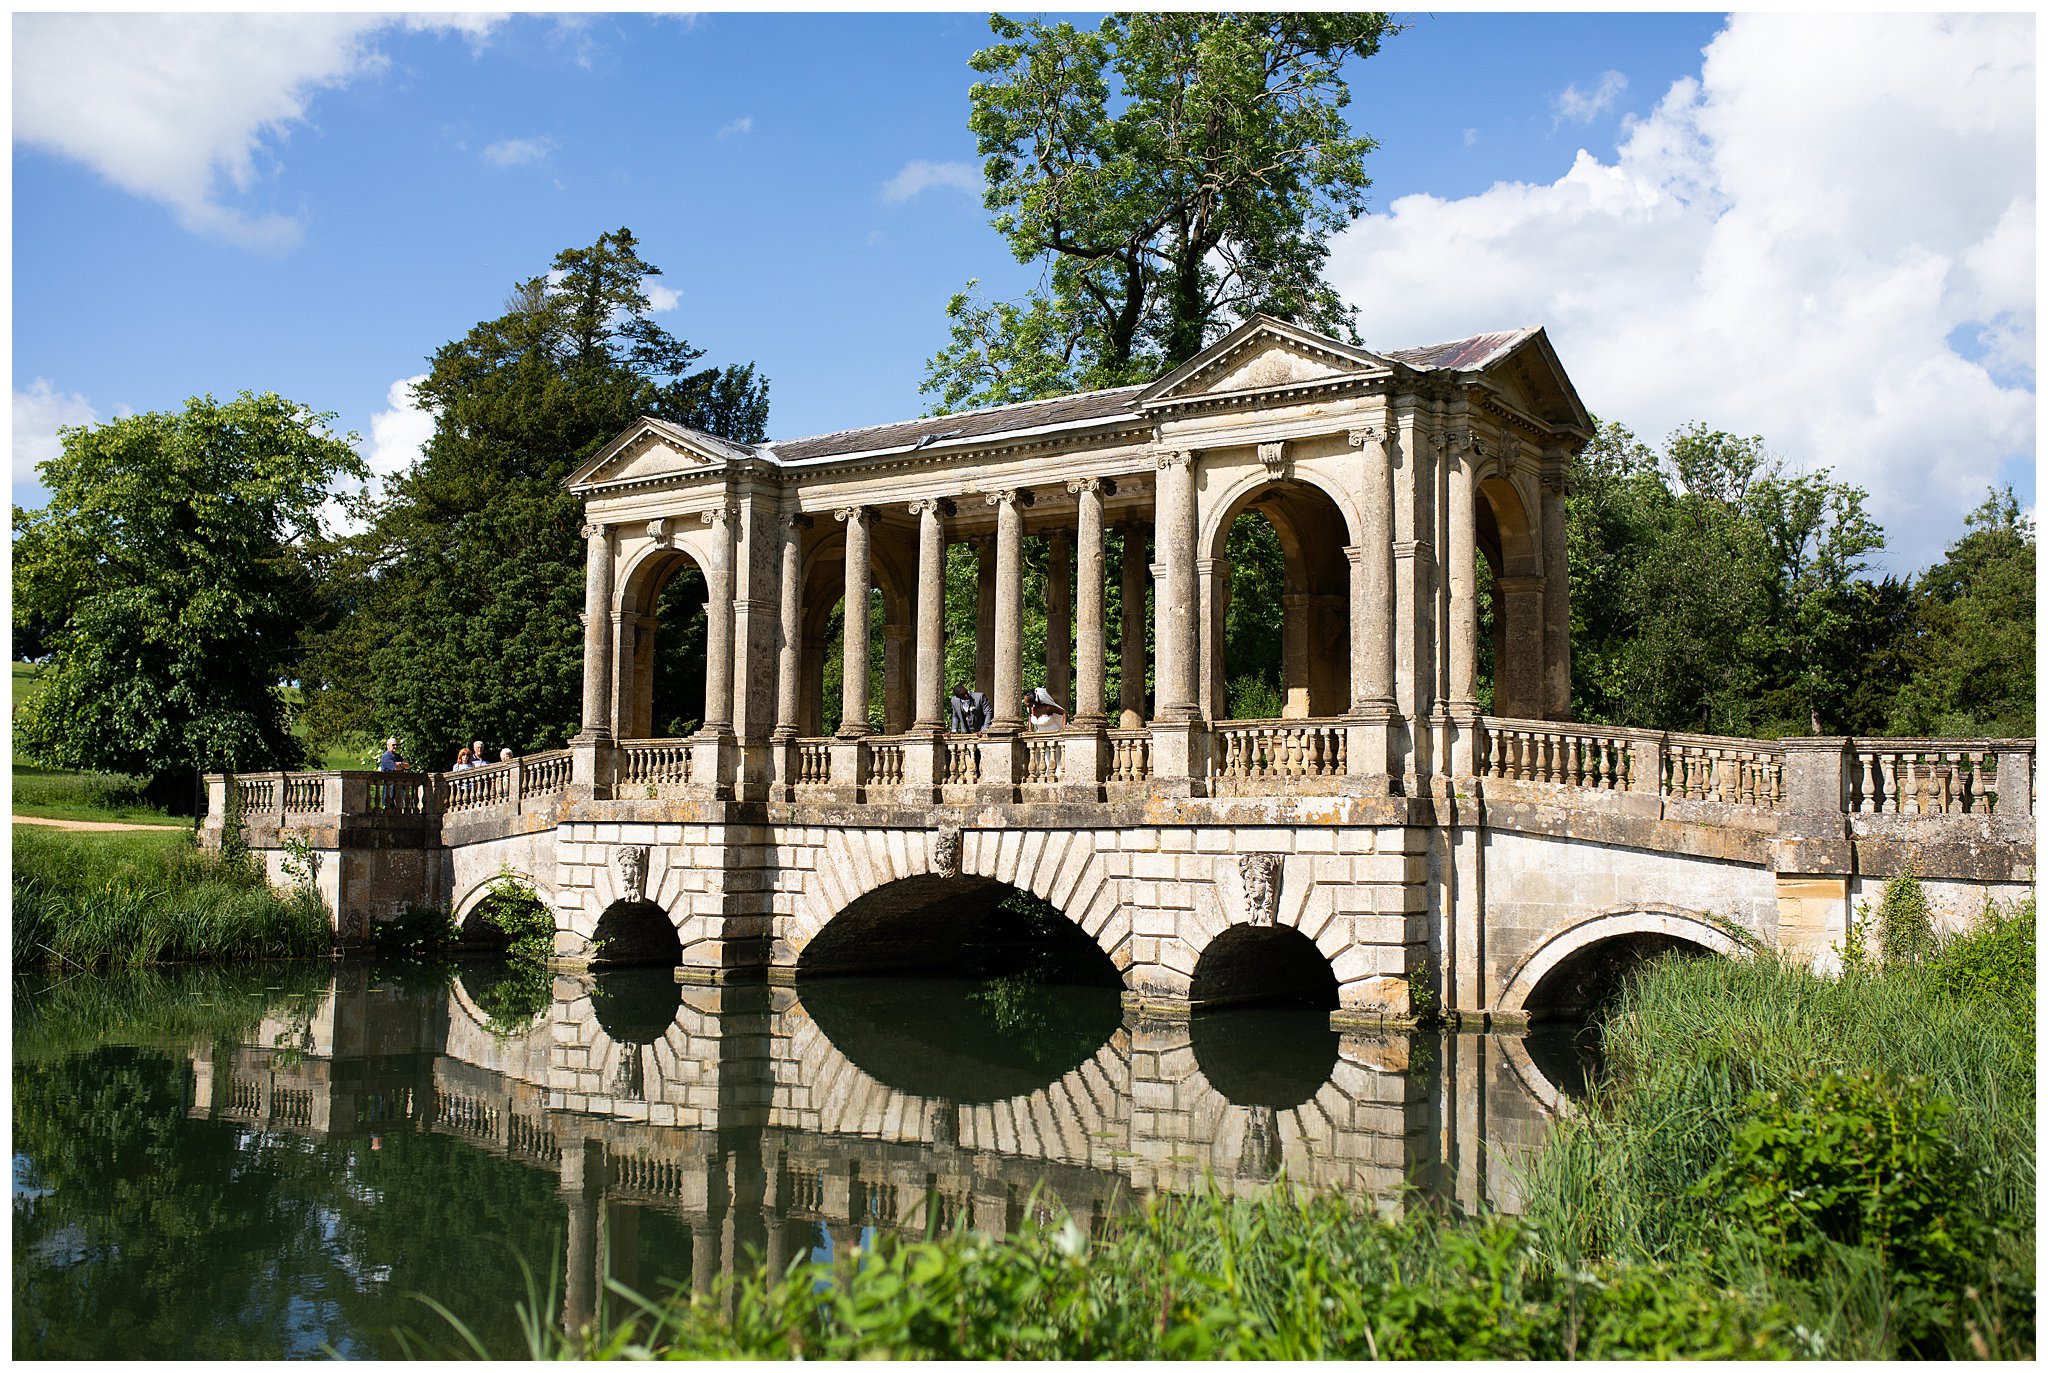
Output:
top-left (1331, 14), bottom-right (2036, 572)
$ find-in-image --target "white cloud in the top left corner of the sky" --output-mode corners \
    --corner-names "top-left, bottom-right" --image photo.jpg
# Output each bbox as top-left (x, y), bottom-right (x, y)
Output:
top-left (14, 14), bottom-right (498, 252)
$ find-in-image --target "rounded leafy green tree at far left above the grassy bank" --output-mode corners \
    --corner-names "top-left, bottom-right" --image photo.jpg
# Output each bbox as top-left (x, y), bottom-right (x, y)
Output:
top-left (14, 391), bottom-right (367, 799)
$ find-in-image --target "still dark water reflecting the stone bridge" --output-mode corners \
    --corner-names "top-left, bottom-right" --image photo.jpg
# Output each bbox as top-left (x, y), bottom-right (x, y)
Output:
top-left (12, 965), bottom-right (1579, 1359)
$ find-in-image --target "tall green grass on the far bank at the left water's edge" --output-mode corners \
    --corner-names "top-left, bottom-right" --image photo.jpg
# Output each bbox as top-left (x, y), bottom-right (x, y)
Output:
top-left (12, 826), bottom-right (334, 971)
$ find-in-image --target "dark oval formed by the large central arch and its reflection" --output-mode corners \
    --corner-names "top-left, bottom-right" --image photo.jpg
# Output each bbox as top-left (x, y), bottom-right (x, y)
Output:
top-left (797, 875), bottom-right (1122, 1102)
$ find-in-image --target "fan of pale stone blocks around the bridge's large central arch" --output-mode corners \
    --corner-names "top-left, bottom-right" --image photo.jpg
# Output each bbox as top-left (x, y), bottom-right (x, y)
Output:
top-left (774, 830), bottom-right (1130, 991)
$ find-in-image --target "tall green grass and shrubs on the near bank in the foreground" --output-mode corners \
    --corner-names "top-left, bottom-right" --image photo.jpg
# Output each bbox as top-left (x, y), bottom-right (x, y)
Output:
top-left (423, 904), bottom-right (2036, 1359)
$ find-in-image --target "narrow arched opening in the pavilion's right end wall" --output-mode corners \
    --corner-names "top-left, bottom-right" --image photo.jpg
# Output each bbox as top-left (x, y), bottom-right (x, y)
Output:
top-left (1473, 475), bottom-right (1544, 719)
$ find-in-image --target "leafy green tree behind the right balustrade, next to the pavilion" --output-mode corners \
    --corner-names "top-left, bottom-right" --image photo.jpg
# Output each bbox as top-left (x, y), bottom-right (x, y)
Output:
top-left (1567, 424), bottom-right (1901, 738)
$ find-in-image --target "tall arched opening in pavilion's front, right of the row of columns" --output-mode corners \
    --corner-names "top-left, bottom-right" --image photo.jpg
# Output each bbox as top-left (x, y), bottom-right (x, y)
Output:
top-left (1202, 482), bottom-right (1352, 719)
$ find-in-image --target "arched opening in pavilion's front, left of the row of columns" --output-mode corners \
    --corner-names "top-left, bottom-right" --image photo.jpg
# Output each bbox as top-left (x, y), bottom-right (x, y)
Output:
top-left (614, 549), bottom-right (709, 740)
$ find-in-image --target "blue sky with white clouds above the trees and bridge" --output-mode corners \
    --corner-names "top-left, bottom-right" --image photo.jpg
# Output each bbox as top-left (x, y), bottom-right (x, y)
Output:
top-left (12, 12), bottom-right (2034, 570)
